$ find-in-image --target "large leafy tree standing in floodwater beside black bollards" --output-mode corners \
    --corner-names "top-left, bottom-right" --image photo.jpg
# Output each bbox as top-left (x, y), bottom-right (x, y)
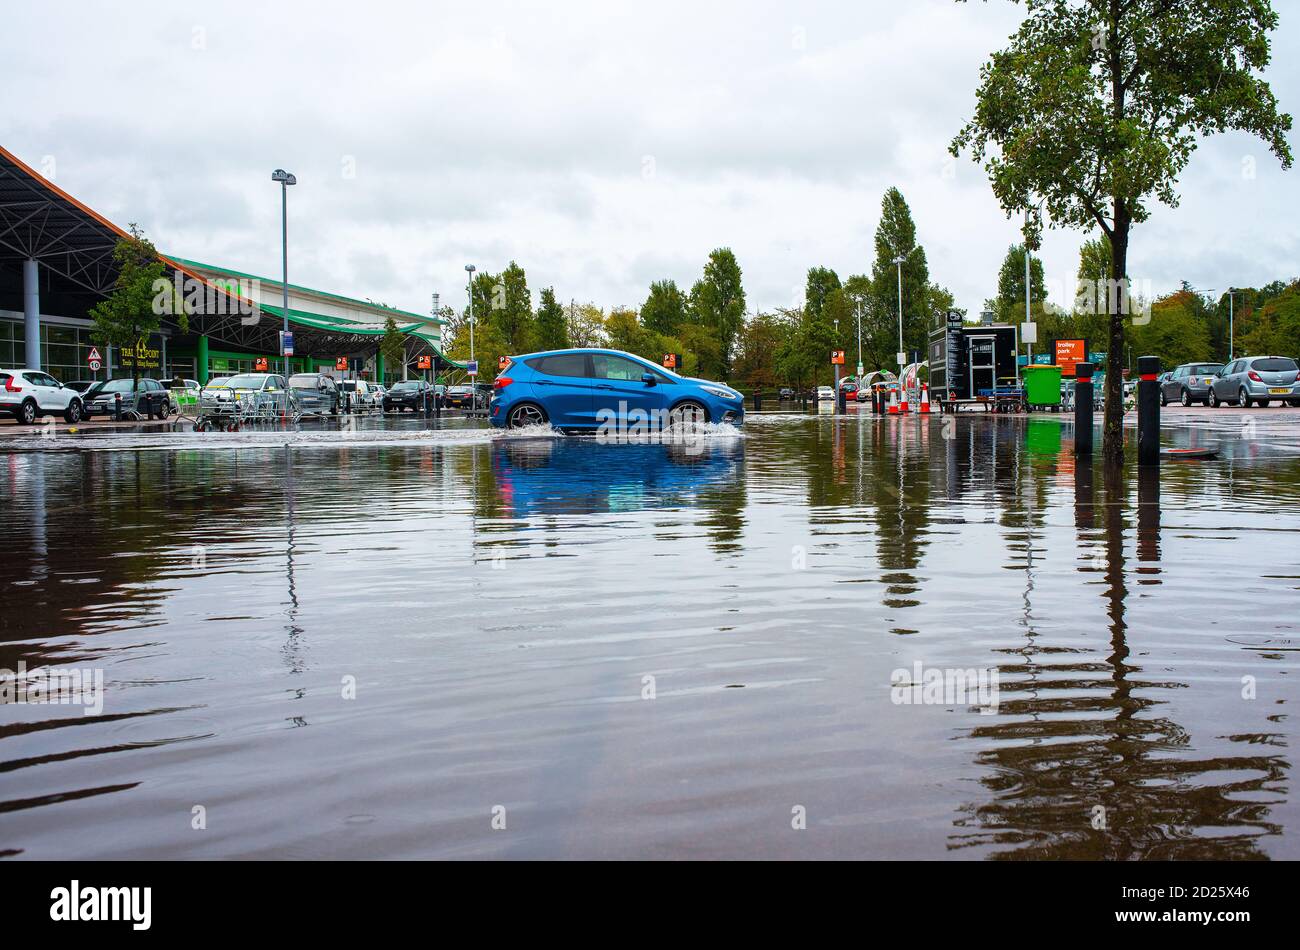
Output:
top-left (950, 0), bottom-right (1291, 464)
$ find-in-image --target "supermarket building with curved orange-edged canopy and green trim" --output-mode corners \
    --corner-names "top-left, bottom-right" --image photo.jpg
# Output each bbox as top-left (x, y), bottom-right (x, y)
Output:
top-left (0, 148), bottom-right (464, 383)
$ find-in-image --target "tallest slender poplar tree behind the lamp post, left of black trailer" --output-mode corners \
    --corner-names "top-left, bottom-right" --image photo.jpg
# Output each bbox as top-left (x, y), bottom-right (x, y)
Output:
top-left (871, 188), bottom-right (930, 370)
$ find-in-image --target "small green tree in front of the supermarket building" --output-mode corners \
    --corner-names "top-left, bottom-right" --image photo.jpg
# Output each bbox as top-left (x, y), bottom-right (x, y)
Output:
top-left (90, 224), bottom-right (167, 385)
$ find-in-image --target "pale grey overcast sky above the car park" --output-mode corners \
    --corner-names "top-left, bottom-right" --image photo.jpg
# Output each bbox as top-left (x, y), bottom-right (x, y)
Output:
top-left (0, 0), bottom-right (1300, 319)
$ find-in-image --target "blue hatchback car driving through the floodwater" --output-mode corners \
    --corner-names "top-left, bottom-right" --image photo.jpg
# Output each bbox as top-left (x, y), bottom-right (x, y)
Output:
top-left (489, 350), bottom-right (745, 430)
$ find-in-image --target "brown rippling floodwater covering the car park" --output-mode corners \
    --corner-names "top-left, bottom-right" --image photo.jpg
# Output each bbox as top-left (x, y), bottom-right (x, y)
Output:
top-left (0, 411), bottom-right (1300, 860)
